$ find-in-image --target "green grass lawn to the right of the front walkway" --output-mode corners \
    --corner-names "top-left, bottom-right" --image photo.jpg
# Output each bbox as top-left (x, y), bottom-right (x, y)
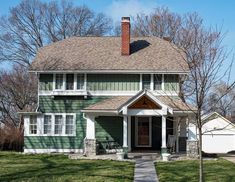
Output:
top-left (156, 159), bottom-right (235, 182)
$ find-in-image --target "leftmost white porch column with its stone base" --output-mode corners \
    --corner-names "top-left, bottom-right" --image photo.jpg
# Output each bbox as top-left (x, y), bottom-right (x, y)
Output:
top-left (84, 115), bottom-right (96, 156)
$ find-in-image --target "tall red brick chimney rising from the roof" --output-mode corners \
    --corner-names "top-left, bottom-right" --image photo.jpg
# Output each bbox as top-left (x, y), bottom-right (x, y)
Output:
top-left (122, 17), bottom-right (130, 56)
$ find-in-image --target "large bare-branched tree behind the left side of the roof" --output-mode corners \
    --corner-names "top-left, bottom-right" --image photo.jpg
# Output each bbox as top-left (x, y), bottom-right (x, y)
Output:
top-left (0, 0), bottom-right (112, 66)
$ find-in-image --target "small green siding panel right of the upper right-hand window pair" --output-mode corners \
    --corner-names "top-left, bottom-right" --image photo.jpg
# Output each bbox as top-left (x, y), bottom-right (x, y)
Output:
top-left (164, 74), bottom-right (179, 92)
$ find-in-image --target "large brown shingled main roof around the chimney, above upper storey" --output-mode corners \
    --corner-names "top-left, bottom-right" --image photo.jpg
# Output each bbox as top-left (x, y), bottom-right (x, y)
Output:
top-left (30, 37), bottom-right (188, 72)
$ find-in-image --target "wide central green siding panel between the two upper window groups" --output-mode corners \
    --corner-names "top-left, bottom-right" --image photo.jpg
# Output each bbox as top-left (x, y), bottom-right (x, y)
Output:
top-left (87, 74), bottom-right (140, 91)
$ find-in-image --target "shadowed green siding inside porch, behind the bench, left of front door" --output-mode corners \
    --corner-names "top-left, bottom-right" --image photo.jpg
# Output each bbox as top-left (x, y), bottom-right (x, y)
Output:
top-left (95, 116), bottom-right (123, 149)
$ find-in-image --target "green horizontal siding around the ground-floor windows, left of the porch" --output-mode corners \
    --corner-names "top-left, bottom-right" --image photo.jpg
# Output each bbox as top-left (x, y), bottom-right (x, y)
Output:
top-left (24, 96), bottom-right (107, 149)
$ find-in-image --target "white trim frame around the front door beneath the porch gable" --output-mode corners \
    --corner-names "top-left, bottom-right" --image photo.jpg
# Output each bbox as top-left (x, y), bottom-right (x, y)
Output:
top-left (135, 116), bottom-right (152, 147)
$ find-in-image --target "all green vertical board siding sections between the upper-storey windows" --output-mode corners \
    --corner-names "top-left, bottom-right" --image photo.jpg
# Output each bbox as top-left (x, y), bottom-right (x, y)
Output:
top-left (39, 74), bottom-right (179, 91)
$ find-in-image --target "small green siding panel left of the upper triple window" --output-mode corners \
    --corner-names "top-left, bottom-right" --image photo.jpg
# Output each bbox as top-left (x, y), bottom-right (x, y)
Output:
top-left (39, 74), bottom-right (53, 90)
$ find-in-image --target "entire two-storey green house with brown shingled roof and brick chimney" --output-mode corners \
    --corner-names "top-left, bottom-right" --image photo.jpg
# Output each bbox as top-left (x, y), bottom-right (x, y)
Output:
top-left (22, 17), bottom-right (196, 158)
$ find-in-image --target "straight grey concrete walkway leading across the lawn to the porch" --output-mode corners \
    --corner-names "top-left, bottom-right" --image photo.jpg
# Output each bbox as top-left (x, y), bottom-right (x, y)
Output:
top-left (134, 159), bottom-right (159, 182)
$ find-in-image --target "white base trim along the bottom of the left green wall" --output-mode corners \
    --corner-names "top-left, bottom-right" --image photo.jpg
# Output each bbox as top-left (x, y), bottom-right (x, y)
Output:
top-left (24, 148), bottom-right (83, 154)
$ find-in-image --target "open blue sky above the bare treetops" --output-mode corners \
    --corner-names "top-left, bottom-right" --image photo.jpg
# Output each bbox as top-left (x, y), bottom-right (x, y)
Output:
top-left (0, 0), bottom-right (235, 80)
